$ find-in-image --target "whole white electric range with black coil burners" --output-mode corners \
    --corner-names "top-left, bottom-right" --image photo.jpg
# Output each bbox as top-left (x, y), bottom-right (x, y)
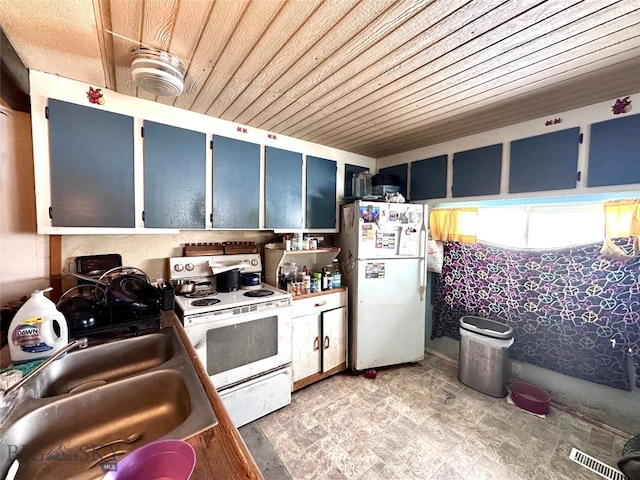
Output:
top-left (169, 254), bottom-right (292, 427)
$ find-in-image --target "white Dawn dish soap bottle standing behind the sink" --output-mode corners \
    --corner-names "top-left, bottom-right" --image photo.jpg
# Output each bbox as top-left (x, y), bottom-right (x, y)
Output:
top-left (8, 287), bottom-right (69, 365)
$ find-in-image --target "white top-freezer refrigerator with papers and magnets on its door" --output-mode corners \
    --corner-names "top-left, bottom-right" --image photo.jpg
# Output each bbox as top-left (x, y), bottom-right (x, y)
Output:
top-left (338, 200), bottom-right (427, 371)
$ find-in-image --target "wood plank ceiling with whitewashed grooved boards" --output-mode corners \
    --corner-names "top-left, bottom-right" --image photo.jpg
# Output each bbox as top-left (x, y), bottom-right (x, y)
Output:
top-left (0, 0), bottom-right (640, 158)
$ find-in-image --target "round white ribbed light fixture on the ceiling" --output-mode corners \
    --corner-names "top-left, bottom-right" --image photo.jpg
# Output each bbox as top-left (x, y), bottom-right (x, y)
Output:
top-left (129, 47), bottom-right (185, 97)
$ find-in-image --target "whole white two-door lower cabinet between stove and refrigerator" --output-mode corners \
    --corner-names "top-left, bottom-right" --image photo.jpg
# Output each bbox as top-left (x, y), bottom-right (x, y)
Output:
top-left (292, 288), bottom-right (347, 390)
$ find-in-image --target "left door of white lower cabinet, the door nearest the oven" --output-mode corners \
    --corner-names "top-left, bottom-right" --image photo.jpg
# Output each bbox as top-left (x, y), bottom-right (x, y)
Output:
top-left (292, 314), bottom-right (322, 382)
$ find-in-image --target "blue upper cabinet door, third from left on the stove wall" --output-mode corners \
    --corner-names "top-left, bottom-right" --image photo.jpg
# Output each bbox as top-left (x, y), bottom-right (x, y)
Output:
top-left (213, 135), bottom-right (260, 228)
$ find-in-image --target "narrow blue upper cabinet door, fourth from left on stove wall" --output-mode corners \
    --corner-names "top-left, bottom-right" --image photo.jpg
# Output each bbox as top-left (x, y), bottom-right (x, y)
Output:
top-left (265, 147), bottom-right (303, 230)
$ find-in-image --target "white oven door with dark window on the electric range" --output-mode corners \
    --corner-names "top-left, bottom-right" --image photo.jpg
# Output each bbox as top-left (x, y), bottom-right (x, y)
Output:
top-left (184, 305), bottom-right (291, 391)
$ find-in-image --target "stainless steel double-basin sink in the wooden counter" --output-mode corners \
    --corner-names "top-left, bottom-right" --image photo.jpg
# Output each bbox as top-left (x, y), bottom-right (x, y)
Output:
top-left (0, 327), bottom-right (217, 480)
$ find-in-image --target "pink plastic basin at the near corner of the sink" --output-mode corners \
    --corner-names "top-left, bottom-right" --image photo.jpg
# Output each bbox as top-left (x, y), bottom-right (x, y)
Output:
top-left (103, 440), bottom-right (196, 480)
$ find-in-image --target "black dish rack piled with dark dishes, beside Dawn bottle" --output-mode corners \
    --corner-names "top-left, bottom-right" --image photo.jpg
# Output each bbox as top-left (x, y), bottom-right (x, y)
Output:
top-left (57, 254), bottom-right (174, 339)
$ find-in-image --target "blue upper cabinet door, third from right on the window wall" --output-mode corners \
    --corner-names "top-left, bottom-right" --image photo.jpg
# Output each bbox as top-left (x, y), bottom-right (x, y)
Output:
top-left (451, 143), bottom-right (502, 197)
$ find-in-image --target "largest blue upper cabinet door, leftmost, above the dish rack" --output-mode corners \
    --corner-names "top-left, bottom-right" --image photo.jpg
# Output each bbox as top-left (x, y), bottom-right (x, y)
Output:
top-left (47, 99), bottom-right (135, 228)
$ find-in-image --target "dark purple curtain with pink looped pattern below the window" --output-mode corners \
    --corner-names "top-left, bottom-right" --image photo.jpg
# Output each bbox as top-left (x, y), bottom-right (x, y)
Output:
top-left (432, 239), bottom-right (640, 390)
